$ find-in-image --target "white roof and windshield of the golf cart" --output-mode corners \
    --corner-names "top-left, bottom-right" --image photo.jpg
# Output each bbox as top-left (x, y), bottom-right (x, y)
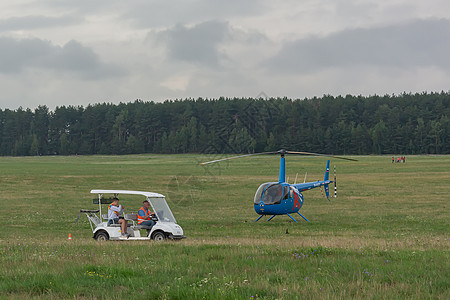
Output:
top-left (91, 190), bottom-right (177, 223)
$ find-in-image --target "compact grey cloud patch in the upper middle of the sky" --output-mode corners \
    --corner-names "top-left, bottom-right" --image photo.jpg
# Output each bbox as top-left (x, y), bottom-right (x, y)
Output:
top-left (160, 21), bottom-right (229, 67)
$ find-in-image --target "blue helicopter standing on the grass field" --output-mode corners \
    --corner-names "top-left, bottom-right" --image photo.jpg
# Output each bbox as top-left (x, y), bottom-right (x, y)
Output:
top-left (200, 149), bottom-right (357, 223)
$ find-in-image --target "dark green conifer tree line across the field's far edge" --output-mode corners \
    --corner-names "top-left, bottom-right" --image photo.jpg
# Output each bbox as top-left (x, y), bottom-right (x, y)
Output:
top-left (0, 92), bottom-right (450, 156)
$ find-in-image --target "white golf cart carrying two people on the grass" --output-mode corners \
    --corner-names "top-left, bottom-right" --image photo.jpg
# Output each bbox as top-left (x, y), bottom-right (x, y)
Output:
top-left (77, 190), bottom-right (185, 241)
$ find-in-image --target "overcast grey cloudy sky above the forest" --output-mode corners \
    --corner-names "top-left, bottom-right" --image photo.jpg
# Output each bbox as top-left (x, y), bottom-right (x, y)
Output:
top-left (0, 0), bottom-right (450, 109)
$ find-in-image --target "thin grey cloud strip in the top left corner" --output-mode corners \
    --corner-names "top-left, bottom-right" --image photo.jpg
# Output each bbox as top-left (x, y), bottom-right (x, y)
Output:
top-left (0, 15), bottom-right (82, 32)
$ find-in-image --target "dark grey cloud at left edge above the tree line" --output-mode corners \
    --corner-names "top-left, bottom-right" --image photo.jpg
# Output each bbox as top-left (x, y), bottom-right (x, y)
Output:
top-left (0, 37), bottom-right (123, 79)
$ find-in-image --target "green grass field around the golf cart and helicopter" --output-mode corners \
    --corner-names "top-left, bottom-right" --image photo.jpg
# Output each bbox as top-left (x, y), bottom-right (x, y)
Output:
top-left (0, 154), bottom-right (450, 299)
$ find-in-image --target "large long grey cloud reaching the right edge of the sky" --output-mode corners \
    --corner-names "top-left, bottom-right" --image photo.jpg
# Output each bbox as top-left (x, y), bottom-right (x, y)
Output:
top-left (266, 19), bottom-right (450, 73)
